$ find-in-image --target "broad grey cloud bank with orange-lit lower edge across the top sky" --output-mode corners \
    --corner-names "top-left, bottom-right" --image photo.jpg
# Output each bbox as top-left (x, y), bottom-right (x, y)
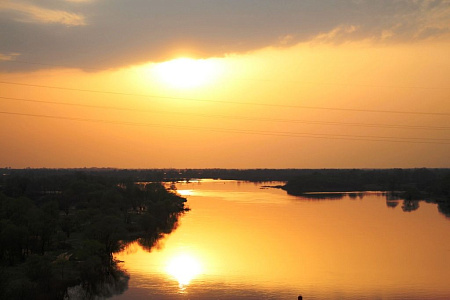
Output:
top-left (0, 0), bottom-right (450, 71)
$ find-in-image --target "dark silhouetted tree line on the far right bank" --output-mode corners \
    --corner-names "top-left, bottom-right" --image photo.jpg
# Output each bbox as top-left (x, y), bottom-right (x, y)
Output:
top-left (282, 168), bottom-right (450, 217)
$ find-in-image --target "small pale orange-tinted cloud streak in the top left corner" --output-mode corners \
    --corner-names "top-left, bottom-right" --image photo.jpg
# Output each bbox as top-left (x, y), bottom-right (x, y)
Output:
top-left (0, 2), bottom-right (86, 26)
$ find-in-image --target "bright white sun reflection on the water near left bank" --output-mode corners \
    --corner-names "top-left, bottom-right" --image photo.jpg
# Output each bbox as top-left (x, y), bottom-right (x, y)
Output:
top-left (166, 254), bottom-right (202, 288)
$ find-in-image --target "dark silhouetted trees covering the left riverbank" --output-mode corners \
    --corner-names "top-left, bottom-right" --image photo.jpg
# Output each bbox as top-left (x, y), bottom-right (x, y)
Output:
top-left (0, 170), bottom-right (187, 299)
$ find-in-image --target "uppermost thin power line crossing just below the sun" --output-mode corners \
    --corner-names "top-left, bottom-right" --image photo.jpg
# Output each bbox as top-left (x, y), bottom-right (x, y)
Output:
top-left (0, 81), bottom-right (450, 116)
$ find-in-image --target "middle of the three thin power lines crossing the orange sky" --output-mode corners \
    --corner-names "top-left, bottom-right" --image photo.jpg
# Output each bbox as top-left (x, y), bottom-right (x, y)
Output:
top-left (0, 96), bottom-right (450, 130)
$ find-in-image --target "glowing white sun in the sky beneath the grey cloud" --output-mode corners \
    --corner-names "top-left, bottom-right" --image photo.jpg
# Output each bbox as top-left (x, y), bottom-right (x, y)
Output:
top-left (153, 57), bottom-right (220, 89)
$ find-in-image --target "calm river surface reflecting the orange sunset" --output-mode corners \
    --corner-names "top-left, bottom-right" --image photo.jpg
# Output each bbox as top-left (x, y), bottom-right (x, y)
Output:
top-left (114, 180), bottom-right (450, 300)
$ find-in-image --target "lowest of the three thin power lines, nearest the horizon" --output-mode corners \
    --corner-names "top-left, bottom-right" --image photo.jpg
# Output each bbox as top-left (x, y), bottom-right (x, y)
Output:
top-left (0, 111), bottom-right (450, 145)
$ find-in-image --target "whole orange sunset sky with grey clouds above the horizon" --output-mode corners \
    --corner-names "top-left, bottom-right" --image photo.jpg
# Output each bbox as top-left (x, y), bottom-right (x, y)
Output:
top-left (0, 0), bottom-right (450, 168)
